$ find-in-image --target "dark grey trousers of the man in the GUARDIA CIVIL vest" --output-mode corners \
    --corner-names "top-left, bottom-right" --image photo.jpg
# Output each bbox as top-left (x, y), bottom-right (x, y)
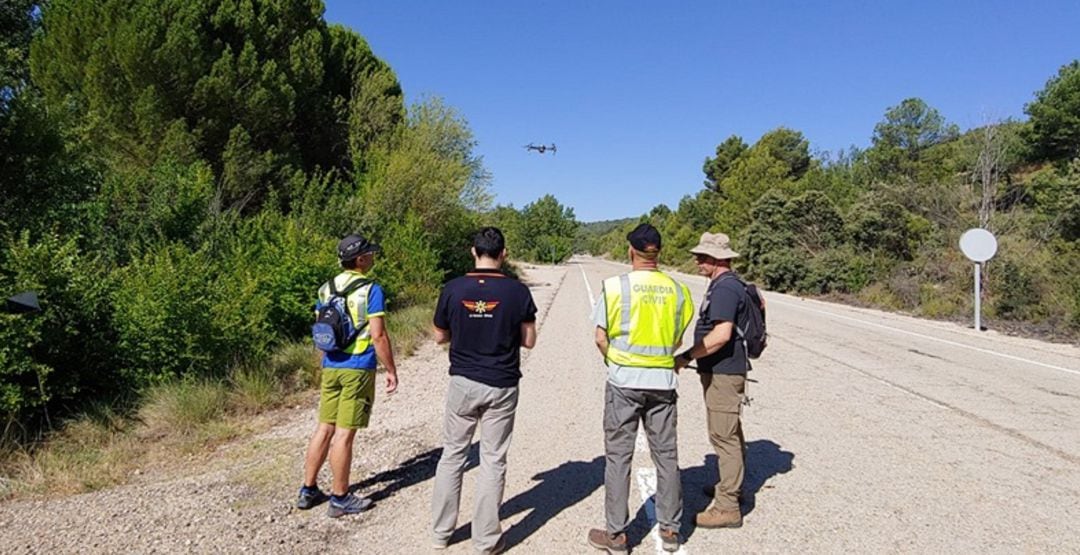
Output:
top-left (604, 383), bottom-right (683, 534)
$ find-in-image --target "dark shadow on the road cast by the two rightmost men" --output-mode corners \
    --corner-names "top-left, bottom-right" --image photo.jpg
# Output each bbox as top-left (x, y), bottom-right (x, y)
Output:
top-left (665, 439), bottom-right (795, 539)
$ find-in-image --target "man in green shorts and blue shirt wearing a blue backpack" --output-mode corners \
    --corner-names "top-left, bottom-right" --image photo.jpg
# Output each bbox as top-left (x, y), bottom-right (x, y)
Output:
top-left (296, 234), bottom-right (397, 517)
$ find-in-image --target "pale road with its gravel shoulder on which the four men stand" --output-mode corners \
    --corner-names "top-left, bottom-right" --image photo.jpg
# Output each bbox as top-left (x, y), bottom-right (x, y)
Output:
top-left (0, 258), bottom-right (1080, 555)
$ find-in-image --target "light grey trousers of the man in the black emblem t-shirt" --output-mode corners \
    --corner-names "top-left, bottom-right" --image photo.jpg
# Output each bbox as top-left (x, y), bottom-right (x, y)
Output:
top-left (431, 376), bottom-right (517, 552)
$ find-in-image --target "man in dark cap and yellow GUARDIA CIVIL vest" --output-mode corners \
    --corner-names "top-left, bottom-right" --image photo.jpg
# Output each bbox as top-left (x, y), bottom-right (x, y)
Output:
top-left (589, 224), bottom-right (693, 553)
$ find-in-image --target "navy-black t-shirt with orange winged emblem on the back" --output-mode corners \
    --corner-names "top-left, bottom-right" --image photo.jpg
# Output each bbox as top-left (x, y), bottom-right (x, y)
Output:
top-left (434, 270), bottom-right (537, 388)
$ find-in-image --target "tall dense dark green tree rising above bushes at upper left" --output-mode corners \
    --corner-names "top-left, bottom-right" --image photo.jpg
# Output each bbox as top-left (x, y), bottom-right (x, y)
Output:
top-left (30, 0), bottom-right (404, 212)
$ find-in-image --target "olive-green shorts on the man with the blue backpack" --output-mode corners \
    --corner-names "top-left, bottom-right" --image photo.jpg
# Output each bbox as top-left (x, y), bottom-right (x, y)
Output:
top-left (319, 368), bottom-right (375, 430)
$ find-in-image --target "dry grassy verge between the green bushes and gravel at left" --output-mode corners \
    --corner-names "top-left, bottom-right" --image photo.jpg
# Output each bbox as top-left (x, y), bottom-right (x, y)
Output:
top-left (0, 298), bottom-right (433, 499)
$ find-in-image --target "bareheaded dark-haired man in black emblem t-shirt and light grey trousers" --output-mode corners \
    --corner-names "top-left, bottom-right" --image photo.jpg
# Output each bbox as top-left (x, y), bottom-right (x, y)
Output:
top-left (432, 228), bottom-right (537, 554)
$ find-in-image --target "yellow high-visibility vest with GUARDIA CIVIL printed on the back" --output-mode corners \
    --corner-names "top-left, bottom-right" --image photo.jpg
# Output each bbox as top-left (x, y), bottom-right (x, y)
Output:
top-left (604, 270), bottom-right (693, 368)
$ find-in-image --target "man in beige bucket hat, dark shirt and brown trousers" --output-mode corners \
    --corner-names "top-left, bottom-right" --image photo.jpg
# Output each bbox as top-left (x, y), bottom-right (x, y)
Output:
top-left (675, 228), bottom-right (751, 528)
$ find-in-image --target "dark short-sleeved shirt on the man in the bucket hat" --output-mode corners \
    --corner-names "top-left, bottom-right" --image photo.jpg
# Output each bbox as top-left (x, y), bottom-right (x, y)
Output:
top-left (693, 273), bottom-right (751, 374)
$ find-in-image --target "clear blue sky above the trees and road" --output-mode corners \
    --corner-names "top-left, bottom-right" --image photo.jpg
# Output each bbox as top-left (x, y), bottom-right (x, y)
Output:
top-left (326, 0), bottom-right (1080, 221)
